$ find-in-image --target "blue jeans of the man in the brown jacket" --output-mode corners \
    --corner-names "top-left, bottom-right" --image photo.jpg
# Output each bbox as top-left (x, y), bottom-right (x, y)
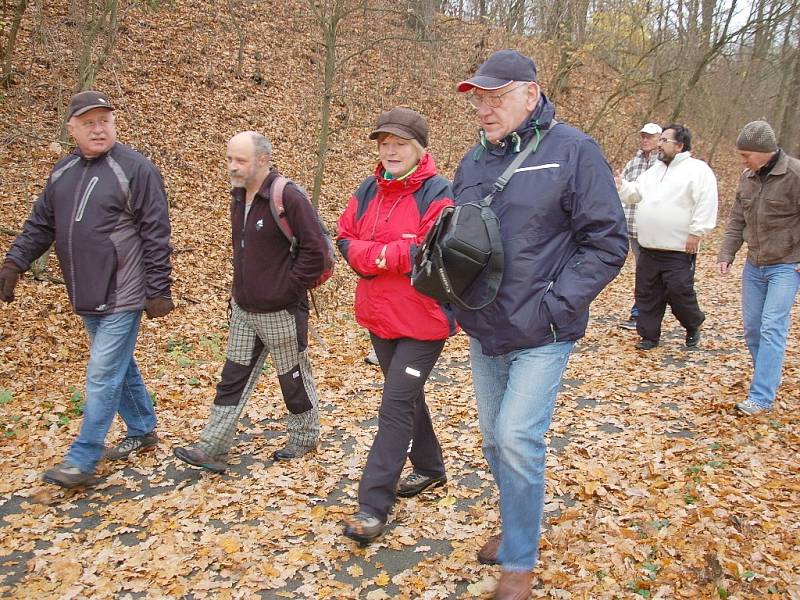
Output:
top-left (742, 261), bottom-right (800, 408)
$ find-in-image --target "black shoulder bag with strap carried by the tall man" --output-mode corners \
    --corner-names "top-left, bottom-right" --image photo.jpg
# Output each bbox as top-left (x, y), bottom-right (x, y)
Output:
top-left (411, 120), bottom-right (556, 310)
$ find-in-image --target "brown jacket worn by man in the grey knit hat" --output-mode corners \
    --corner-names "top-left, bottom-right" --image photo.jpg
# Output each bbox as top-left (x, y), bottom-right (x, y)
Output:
top-left (717, 150), bottom-right (800, 267)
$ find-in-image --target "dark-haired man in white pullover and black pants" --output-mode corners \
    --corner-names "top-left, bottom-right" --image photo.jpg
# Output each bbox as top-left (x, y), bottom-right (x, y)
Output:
top-left (617, 124), bottom-right (717, 350)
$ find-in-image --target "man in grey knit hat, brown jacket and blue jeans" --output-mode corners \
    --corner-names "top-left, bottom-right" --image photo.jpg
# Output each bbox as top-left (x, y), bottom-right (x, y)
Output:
top-left (717, 121), bottom-right (800, 415)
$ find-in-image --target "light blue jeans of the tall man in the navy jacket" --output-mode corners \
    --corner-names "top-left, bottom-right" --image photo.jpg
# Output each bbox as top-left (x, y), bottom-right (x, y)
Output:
top-left (469, 338), bottom-right (574, 571)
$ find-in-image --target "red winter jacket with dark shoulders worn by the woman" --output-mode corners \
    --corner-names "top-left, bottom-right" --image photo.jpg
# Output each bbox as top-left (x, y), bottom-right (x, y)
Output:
top-left (337, 153), bottom-right (456, 340)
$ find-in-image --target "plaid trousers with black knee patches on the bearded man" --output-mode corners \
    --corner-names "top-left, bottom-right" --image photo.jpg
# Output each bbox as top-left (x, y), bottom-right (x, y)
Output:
top-left (199, 302), bottom-right (320, 456)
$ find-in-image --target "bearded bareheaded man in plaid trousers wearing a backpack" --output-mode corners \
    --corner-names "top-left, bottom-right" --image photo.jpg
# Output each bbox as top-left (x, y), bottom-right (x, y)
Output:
top-left (175, 131), bottom-right (326, 472)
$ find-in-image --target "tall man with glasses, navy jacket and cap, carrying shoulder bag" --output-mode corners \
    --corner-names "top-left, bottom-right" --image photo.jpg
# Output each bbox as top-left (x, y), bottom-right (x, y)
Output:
top-left (453, 50), bottom-right (628, 600)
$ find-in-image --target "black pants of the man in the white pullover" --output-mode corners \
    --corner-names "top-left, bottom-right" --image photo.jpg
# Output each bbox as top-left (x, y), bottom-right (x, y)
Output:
top-left (636, 248), bottom-right (706, 341)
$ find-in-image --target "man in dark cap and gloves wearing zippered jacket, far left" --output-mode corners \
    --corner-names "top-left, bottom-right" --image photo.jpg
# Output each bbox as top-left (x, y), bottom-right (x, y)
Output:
top-left (0, 91), bottom-right (173, 488)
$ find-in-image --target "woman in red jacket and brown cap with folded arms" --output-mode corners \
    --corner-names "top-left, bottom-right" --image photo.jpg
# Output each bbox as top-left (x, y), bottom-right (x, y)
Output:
top-left (337, 108), bottom-right (456, 544)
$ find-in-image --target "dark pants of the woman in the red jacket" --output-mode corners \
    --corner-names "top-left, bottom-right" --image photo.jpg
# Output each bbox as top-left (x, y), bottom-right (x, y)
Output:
top-left (358, 335), bottom-right (445, 521)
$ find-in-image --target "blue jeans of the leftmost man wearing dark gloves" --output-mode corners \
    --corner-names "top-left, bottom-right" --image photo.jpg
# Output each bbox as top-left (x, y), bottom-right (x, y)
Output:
top-left (65, 311), bottom-right (156, 473)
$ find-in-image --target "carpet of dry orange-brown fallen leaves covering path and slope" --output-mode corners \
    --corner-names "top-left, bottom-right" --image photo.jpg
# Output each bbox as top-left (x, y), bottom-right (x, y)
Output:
top-left (0, 0), bottom-right (800, 600)
